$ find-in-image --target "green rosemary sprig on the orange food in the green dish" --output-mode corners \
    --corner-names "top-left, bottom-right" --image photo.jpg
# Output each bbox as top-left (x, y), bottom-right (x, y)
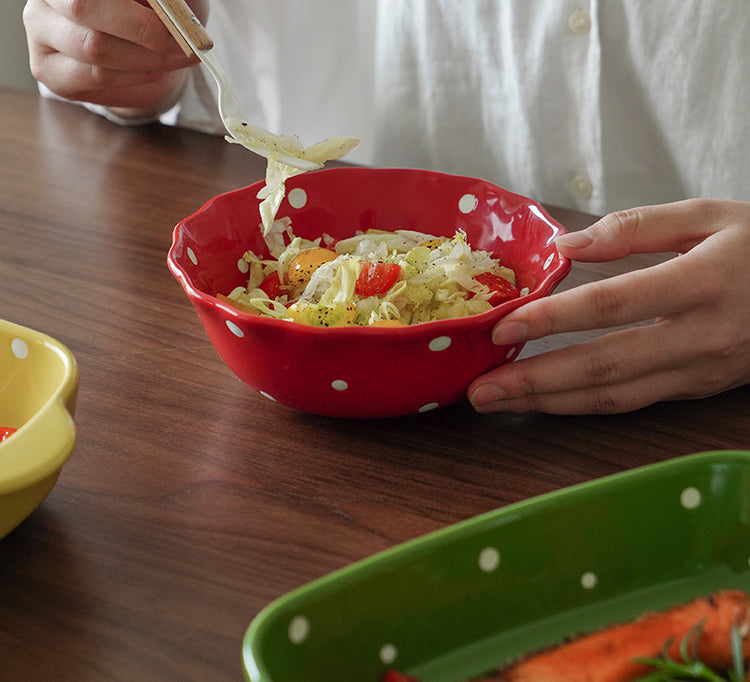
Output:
top-left (636, 621), bottom-right (745, 682)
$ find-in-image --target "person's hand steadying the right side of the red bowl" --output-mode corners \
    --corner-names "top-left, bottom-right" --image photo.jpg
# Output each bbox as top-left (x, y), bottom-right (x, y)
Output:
top-left (468, 199), bottom-right (750, 414)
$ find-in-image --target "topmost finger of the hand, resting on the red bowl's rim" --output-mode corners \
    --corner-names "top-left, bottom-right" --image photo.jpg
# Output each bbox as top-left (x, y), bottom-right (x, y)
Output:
top-left (555, 199), bottom-right (721, 262)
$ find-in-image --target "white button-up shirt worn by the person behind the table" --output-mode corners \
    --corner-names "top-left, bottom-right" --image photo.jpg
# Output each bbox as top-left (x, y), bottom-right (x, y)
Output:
top-left (154, 0), bottom-right (750, 214)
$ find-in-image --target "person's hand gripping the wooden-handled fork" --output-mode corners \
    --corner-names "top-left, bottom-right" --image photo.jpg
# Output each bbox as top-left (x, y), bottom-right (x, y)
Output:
top-left (23, 0), bottom-right (208, 118)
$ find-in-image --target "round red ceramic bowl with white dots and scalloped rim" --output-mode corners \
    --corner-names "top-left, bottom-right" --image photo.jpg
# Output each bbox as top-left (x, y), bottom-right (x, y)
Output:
top-left (168, 168), bottom-right (570, 417)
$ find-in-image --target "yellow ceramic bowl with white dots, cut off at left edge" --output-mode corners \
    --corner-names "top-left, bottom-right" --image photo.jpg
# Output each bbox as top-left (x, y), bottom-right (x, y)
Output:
top-left (0, 320), bottom-right (78, 538)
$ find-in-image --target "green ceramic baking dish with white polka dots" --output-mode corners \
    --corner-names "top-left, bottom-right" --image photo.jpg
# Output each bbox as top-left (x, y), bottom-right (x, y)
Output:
top-left (243, 451), bottom-right (750, 682)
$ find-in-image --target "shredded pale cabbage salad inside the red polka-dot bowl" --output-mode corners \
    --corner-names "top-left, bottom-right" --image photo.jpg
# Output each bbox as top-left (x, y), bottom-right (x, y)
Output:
top-left (223, 227), bottom-right (528, 326)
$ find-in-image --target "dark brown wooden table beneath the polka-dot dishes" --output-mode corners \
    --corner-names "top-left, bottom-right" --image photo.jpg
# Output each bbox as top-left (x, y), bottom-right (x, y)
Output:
top-left (0, 90), bottom-right (750, 682)
